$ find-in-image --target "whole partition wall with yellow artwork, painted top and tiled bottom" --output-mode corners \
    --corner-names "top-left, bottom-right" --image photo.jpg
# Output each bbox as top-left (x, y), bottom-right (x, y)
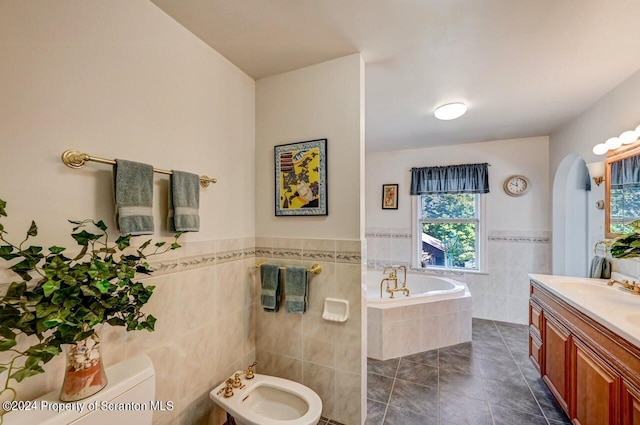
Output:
top-left (256, 55), bottom-right (366, 425)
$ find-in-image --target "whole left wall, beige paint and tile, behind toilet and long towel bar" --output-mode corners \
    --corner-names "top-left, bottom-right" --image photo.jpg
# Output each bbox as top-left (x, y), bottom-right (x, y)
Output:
top-left (0, 0), bottom-right (255, 424)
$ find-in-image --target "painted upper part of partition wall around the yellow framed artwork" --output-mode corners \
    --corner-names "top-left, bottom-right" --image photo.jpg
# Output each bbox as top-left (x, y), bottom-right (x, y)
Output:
top-left (256, 54), bottom-right (364, 239)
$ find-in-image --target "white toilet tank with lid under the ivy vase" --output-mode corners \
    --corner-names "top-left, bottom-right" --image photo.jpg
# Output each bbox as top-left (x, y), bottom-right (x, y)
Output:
top-left (3, 355), bottom-right (158, 425)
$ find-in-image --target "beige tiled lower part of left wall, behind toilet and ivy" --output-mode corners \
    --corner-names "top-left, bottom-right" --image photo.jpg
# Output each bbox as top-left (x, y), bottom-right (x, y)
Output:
top-left (0, 238), bottom-right (255, 425)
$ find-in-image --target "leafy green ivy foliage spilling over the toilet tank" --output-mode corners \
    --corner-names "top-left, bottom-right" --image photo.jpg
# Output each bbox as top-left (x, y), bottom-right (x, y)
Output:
top-left (0, 199), bottom-right (180, 414)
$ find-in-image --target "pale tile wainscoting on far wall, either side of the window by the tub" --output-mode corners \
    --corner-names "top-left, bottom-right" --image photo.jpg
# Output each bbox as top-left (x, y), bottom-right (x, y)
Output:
top-left (366, 229), bottom-right (551, 324)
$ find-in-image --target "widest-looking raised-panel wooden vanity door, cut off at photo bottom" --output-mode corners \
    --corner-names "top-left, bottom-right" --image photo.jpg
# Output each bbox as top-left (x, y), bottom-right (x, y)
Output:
top-left (570, 339), bottom-right (620, 425)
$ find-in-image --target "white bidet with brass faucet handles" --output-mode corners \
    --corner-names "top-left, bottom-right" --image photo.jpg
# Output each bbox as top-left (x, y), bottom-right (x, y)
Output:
top-left (209, 371), bottom-right (322, 425)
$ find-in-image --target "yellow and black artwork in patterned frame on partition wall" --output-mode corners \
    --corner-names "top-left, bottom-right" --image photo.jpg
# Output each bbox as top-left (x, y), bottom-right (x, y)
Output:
top-left (274, 139), bottom-right (329, 216)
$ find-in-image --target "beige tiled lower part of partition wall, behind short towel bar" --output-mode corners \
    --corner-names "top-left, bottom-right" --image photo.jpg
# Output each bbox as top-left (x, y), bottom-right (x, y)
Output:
top-left (253, 237), bottom-right (367, 425)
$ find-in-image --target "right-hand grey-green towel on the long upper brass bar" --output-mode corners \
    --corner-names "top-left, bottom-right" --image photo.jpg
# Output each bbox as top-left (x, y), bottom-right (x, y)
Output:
top-left (167, 170), bottom-right (200, 232)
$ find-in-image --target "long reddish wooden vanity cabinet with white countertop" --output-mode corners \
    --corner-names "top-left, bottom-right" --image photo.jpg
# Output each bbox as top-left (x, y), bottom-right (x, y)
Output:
top-left (529, 274), bottom-right (640, 425)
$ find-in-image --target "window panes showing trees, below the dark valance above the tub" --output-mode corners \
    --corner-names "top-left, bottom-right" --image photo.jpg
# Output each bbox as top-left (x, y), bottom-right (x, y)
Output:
top-left (416, 193), bottom-right (481, 271)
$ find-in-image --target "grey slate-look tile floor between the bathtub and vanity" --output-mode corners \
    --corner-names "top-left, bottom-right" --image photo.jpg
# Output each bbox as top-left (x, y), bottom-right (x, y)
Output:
top-left (364, 319), bottom-right (571, 425)
